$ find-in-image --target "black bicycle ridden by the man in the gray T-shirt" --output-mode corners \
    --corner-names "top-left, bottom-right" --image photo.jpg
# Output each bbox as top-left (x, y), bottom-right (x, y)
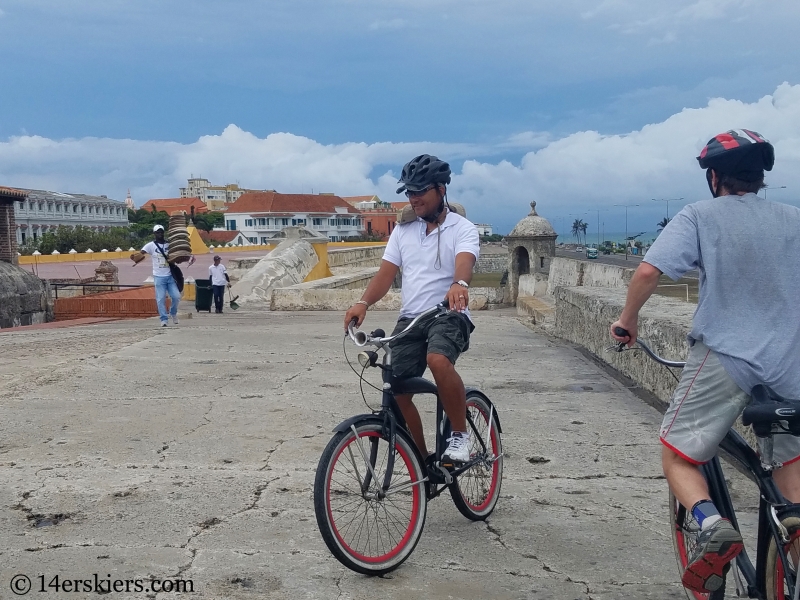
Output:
top-left (610, 327), bottom-right (800, 600)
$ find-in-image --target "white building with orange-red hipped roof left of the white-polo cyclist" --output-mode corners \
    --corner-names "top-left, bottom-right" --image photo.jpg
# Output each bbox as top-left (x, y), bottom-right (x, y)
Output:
top-left (225, 192), bottom-right (364, 244)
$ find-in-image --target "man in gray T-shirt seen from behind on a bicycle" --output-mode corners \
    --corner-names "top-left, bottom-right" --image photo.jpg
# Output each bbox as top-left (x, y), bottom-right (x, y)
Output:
top-left (611, 129), bottom-right (800, 593)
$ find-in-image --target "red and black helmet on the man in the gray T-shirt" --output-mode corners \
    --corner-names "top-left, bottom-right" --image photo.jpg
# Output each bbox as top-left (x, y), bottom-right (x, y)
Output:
top-left (697, 129), bottom-right (775, 181)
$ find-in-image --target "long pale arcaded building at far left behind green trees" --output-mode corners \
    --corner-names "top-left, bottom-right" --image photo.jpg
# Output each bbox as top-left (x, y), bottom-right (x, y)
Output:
top-left (14, 188), bottom-right (128, 244)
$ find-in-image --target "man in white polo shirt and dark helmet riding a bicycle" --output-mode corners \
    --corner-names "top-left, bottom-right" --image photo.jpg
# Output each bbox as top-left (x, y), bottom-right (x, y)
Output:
top-left (344, 154), bottom-right (480, 464)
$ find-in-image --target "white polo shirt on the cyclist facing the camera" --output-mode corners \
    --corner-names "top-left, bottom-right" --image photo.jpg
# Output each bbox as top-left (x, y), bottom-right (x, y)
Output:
top-left (383, 212), bottom-right (480, 317)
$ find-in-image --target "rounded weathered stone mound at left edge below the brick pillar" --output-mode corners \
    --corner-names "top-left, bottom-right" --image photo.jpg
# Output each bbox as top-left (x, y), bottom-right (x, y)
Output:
top-left (0, 261), bottom-right (53, 328)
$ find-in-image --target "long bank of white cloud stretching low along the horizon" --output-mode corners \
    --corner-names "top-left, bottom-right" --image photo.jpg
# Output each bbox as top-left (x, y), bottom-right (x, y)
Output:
top-left (0, 84), bottom-right (800, 233)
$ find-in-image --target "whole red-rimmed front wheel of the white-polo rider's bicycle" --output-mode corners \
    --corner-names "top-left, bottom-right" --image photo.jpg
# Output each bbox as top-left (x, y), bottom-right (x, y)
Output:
top-left (314, 422), bottom-right (427, 575)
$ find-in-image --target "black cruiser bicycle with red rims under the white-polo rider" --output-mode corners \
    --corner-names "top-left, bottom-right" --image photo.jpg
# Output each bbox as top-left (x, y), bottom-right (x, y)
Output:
top-left (314, 302), bottom-right (503, 575)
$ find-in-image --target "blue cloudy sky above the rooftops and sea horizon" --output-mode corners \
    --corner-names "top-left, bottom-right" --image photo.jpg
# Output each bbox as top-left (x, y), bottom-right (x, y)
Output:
top-left (0, 0), bottom-right (800, 238)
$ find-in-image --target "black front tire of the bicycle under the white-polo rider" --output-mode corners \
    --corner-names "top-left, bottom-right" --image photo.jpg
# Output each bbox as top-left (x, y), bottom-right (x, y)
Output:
top-left (314, 420), bottom-right (427, 576)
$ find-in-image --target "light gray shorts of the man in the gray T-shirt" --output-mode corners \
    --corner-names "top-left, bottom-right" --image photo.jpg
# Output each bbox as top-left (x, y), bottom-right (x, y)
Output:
top-left (661, 342), bottom-right (800, 465)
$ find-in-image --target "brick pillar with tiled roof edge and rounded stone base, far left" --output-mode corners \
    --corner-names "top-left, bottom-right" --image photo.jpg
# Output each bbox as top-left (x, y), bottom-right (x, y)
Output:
top-left (0, 187), bottom-right (53, 328)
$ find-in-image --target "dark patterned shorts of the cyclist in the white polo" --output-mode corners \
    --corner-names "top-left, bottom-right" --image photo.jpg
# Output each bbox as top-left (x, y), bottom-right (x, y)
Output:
top-left (391, 311), bottom-right (475, 379)
